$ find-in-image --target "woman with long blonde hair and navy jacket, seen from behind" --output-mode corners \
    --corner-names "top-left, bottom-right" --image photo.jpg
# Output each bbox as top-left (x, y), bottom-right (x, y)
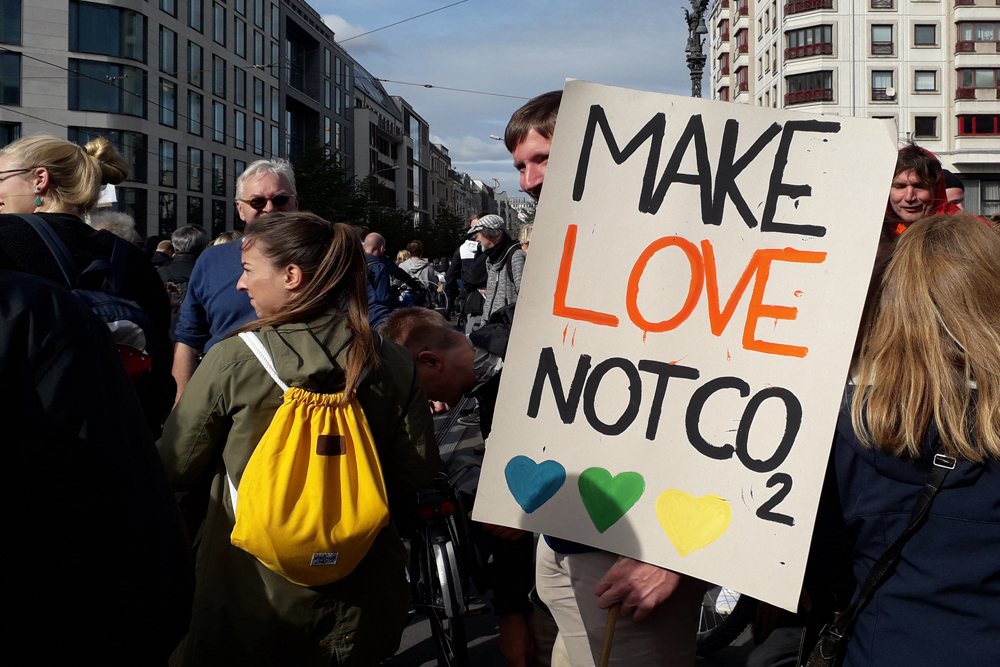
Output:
top-left (807, 214), bottom-right (1000, 667)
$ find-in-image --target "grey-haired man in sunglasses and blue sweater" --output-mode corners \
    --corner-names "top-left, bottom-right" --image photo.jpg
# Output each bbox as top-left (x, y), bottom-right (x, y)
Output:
top-left (173, 158), bottom-right (299, 399)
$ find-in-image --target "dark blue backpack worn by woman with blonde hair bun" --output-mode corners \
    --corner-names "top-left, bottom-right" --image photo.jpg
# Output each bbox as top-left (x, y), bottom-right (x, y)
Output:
top-left (17, 213), bottom-right (159, 383)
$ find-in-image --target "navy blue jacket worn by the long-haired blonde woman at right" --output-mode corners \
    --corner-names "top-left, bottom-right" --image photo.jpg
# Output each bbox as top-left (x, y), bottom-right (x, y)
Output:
top-left (810, 391), bottom-right (1000, 667)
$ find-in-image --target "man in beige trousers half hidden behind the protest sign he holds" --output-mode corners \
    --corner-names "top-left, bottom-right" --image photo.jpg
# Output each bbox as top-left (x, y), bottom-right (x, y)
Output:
top-left (504, 90), bottom-right (703, 666)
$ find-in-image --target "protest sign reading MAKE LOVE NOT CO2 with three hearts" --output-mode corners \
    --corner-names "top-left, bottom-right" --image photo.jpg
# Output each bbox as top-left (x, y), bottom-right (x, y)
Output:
top-left (474, 81), bottom-right (896, 609)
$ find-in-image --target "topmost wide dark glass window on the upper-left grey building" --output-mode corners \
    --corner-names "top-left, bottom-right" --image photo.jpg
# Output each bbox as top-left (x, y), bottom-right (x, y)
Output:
top-left (68, 0), bottom-right (146, 63)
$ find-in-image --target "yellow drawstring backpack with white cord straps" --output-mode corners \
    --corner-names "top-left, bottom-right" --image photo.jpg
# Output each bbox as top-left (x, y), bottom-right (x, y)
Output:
top-left (227, 333), bottom-right (389, 586)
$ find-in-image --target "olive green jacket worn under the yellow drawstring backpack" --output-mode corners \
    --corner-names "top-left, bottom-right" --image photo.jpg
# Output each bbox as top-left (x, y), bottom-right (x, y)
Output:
top-left (157, 319), bottom-right (440, 667)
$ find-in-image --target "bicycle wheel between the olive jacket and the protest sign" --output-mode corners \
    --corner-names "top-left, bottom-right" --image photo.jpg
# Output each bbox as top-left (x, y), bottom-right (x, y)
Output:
top-left (427, 540), bottom-right (469, 667)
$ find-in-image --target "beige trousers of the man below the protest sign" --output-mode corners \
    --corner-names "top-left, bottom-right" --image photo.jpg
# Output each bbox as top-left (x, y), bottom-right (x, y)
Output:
top-left (535, 539), bottom-right (702, 667)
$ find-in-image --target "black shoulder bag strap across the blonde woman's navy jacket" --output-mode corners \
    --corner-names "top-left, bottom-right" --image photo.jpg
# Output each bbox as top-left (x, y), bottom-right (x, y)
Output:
top-left (804, 454), bottom-right (956, 667)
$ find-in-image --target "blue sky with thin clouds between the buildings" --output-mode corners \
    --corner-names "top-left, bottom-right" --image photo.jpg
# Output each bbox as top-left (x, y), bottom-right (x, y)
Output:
top-left (311, 0), bottom-right (707, 196)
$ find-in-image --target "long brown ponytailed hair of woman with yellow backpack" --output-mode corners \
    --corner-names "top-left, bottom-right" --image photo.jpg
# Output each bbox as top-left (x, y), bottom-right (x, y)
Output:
top-left (231, 212), bottom-right (376, 400)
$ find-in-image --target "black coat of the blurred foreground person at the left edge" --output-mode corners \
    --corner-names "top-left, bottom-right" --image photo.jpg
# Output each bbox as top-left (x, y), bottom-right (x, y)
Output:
top-left (0, 270), bottom-right (194, 665)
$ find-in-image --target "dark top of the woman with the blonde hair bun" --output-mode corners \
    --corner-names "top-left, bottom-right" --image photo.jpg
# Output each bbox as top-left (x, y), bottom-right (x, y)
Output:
top-left (0, 213), bottom-right (177, 435)
